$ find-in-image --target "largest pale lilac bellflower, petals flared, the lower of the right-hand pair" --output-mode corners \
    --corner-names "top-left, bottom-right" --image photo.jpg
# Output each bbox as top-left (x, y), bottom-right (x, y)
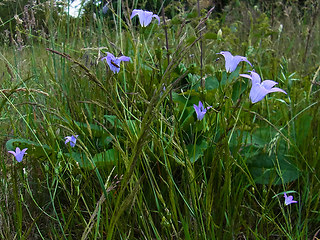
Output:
top-left (240, 71), bottom-right (287, 103)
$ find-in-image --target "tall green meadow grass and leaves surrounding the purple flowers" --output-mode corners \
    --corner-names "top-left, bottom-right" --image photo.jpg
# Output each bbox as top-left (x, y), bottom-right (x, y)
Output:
top-left (0, 1), bottom-right (320, 239)
